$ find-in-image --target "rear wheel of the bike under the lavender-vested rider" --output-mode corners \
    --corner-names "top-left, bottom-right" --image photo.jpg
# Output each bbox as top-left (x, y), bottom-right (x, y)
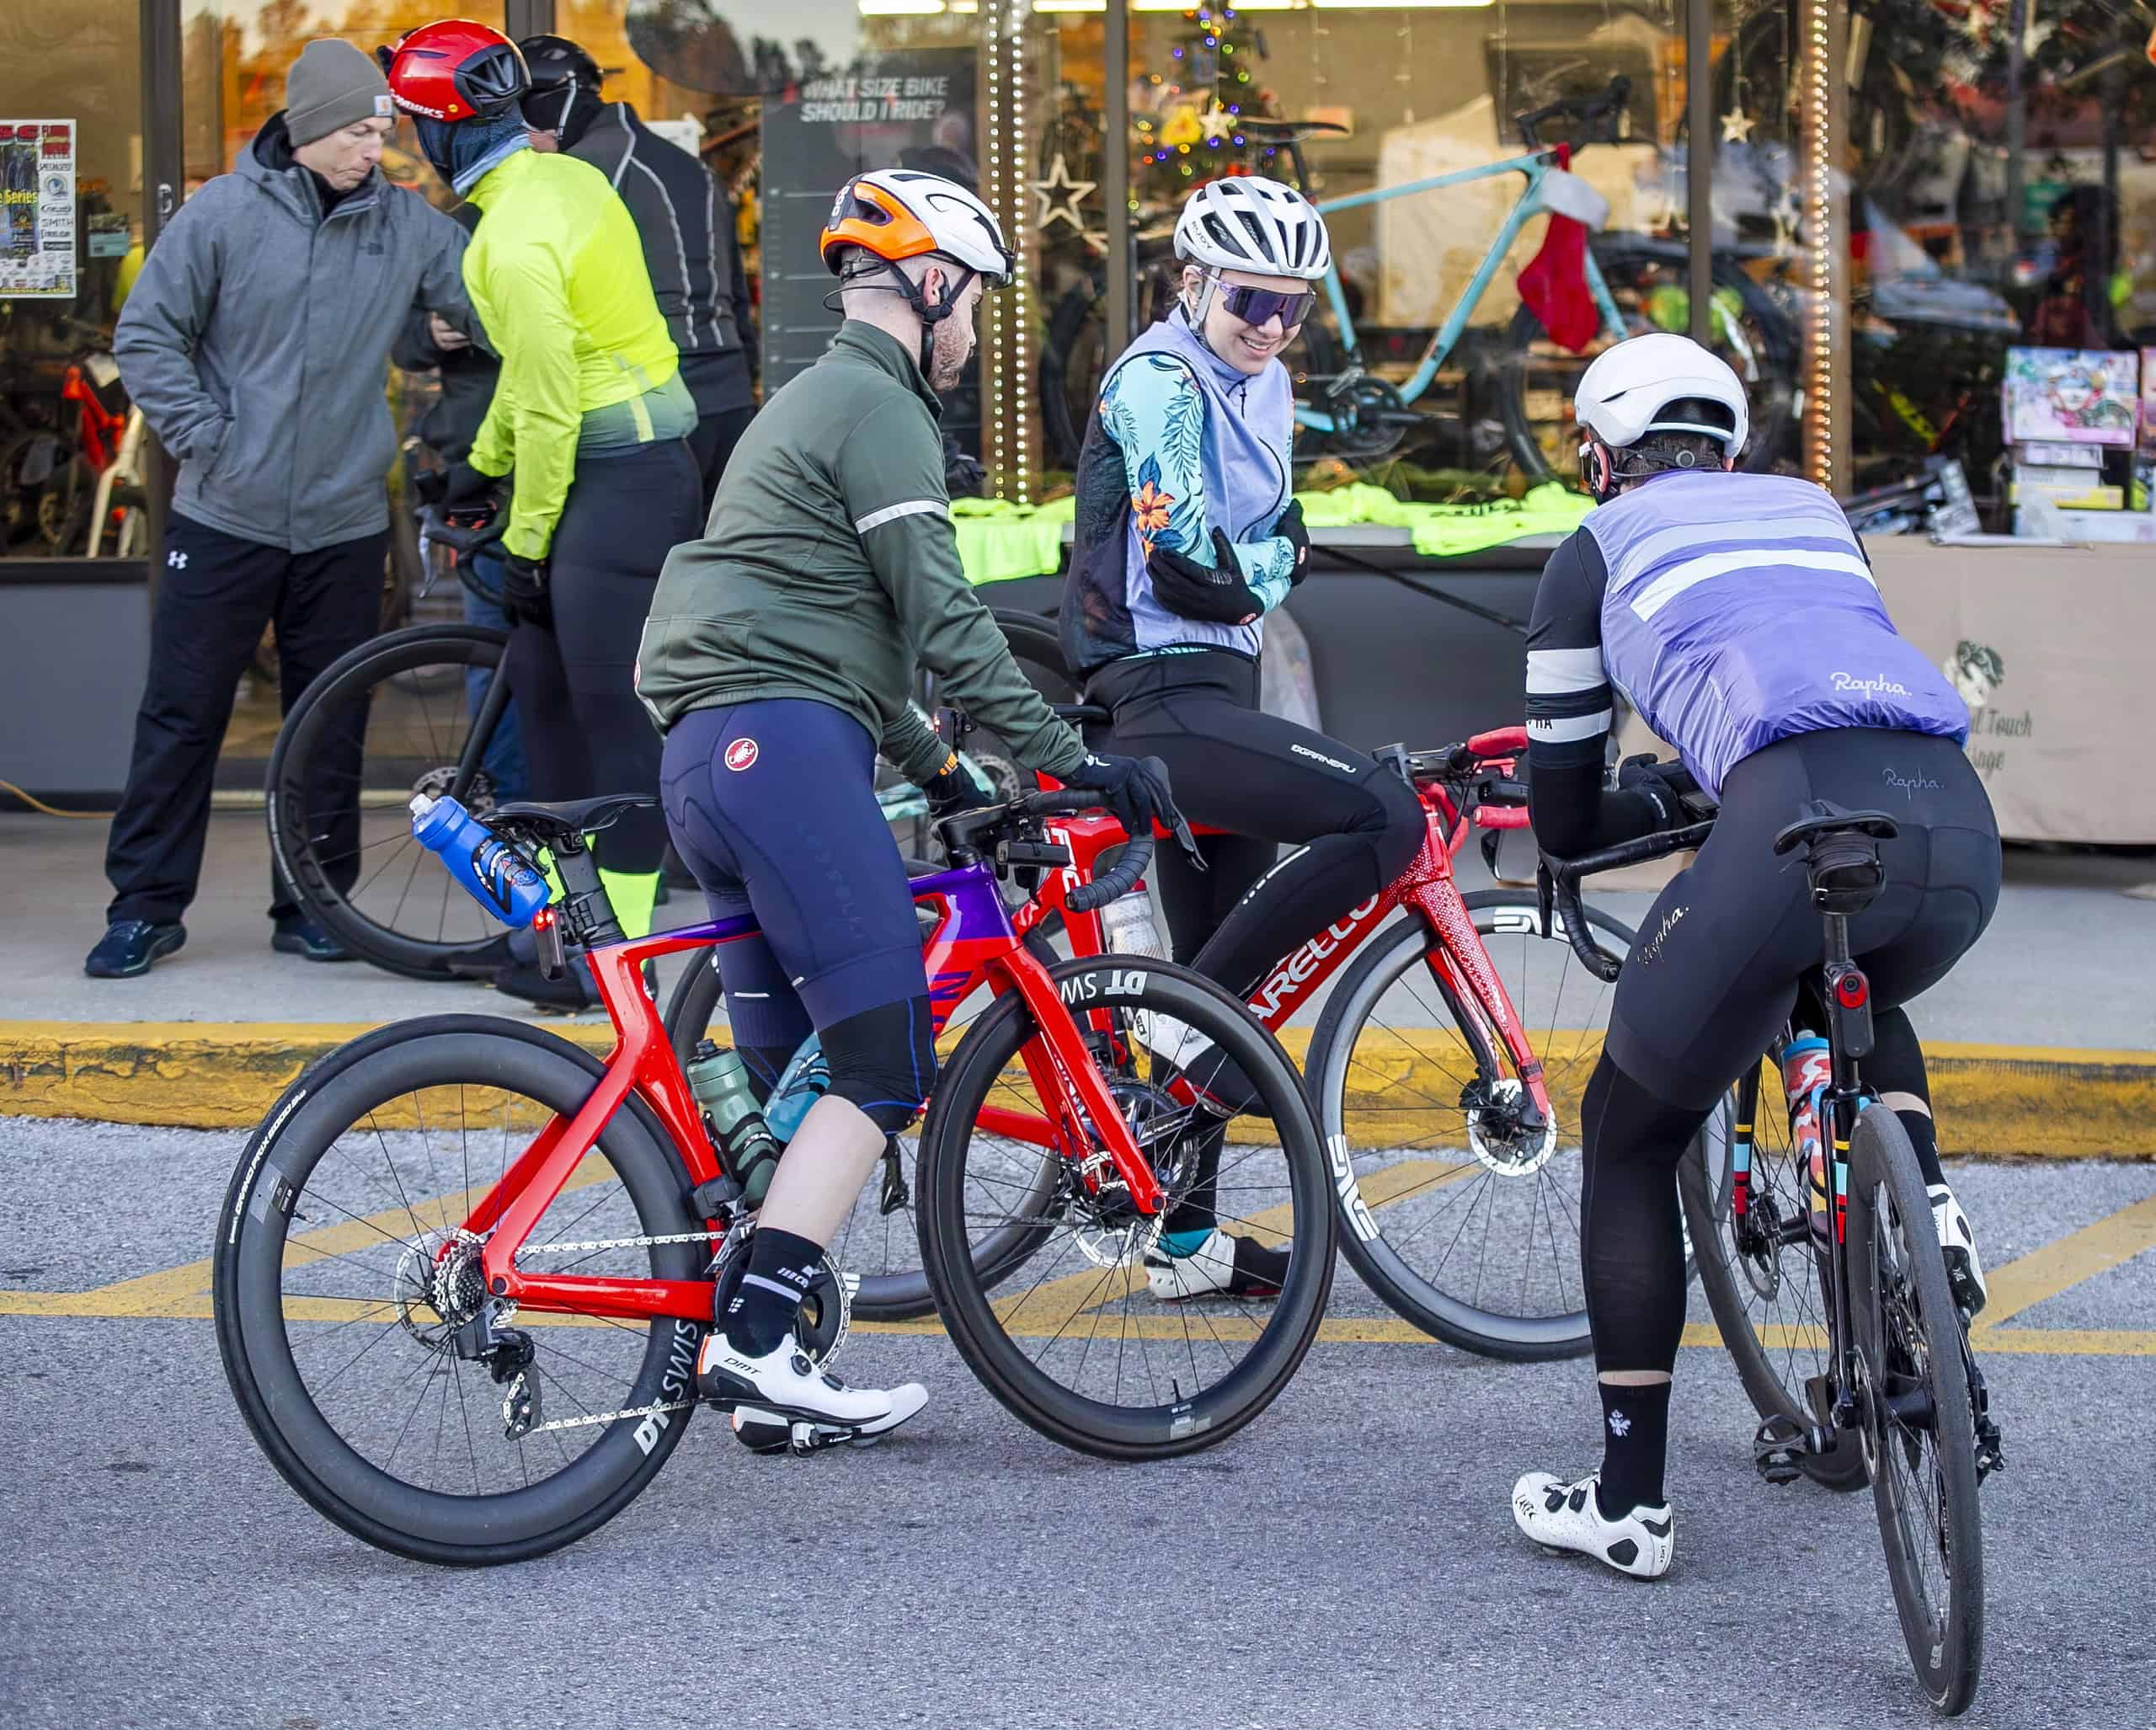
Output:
top-left (1848, 1104), bottom-right (1983, 1715)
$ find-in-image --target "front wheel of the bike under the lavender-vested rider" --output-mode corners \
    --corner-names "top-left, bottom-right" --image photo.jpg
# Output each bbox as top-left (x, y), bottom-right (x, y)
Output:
top-left (1678, 1053), bottom-right (1865, 1491)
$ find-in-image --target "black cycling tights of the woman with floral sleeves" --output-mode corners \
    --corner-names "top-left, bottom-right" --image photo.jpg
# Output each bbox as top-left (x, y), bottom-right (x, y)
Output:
top-left (1086, 649), bottom-right (1423, 995)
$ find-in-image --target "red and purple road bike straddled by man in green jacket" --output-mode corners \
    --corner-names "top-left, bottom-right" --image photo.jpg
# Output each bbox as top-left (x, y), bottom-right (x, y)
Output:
top-left (213, 792), bottom-right (1332, 1564)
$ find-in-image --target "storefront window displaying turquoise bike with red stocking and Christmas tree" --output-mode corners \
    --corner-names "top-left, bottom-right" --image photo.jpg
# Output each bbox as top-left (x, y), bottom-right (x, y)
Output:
top-left (1037, 0), bottom-right (1794, 503)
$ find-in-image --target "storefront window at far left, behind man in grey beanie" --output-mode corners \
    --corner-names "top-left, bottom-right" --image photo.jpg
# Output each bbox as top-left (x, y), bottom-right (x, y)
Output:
top-left (0, 0), bottom-right (147, 558)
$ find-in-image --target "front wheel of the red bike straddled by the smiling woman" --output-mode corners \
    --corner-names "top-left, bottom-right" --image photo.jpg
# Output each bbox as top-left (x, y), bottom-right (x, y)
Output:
top-left (1306, 889), bottom-right (1632, 1361)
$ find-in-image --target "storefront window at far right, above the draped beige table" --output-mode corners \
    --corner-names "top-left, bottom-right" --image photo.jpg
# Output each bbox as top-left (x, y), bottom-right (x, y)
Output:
top-left (1844, 0), bottom-right (2156, 528)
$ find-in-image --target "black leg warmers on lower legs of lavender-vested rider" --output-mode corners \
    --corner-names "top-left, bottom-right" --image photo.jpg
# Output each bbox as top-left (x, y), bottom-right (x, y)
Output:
top-left (1580, 1005), bottom-right (1940, 1374)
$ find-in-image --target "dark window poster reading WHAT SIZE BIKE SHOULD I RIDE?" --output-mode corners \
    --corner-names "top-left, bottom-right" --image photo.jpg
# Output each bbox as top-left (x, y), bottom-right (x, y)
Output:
top-left (761, 47), bottom-right (981, 398)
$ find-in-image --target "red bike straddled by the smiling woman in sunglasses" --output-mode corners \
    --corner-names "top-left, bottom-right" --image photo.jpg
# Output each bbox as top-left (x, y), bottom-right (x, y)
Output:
top-left (666, 703), bottom-right (1632, 1359)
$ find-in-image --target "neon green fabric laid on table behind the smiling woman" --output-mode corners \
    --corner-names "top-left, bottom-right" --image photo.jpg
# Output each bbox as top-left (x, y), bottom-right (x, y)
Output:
top-left (951, 481), bottom-right (1595, 585)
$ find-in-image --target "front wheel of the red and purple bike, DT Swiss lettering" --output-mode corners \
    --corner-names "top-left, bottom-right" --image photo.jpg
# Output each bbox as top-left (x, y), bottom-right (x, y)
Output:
top-left (921, 956), bottom-right (1332, 1460)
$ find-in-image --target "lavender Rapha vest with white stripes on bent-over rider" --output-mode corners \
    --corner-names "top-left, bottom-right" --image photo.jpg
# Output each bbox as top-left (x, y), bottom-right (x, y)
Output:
top-left (1582, 470), bottom-right (1968, 796)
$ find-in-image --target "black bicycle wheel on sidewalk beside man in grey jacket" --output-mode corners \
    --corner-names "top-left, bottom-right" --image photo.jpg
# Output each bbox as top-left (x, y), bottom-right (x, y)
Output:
top-left (267, 626), bottom-right (513, 980)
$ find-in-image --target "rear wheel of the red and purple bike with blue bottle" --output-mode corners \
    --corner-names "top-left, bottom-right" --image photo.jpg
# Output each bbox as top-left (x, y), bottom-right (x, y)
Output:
top-left (213, 1016), bottom-right (712, 1566)
